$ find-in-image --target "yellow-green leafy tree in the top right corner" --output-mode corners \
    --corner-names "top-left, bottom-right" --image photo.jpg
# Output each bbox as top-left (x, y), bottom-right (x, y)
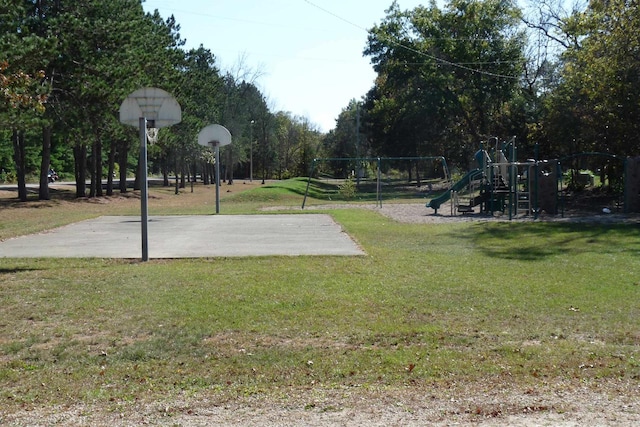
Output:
top-left (561, 0), bottom-right (640, 155)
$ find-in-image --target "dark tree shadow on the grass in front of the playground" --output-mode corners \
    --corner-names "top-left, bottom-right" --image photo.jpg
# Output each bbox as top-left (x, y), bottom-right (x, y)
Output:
top-left (461, 222), bottom-right (640, 261)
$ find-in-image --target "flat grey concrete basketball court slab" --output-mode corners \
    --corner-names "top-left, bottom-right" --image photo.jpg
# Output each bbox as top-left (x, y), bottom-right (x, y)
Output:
top-left (0, 214), bottom-right (364, 259)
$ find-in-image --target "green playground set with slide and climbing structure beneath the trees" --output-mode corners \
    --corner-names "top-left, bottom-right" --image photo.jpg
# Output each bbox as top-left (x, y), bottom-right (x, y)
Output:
top-left (426, 137), bottom-right (640, 219)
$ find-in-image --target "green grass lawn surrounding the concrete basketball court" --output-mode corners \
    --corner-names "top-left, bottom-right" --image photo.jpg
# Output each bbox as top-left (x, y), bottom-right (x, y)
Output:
top-left (0, 181), bottom-right (640, 410)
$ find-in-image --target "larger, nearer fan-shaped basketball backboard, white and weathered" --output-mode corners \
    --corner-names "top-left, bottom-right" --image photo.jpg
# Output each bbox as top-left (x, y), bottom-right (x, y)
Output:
top-left (120, 87), bottom-right (182, 128)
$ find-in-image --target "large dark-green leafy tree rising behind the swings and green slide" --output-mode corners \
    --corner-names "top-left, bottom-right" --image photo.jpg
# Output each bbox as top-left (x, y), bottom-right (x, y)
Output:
top-left (365, 0), bottom-right (524, 166)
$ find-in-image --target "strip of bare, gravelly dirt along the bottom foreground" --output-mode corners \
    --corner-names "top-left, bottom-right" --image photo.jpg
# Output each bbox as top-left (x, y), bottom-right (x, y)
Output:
top-left (0, 381), bottom-right (640, 427)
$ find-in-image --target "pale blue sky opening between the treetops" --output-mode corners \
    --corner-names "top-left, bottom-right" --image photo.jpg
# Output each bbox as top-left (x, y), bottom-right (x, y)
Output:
top-left (143, 0), bottom-right (427, 132)
